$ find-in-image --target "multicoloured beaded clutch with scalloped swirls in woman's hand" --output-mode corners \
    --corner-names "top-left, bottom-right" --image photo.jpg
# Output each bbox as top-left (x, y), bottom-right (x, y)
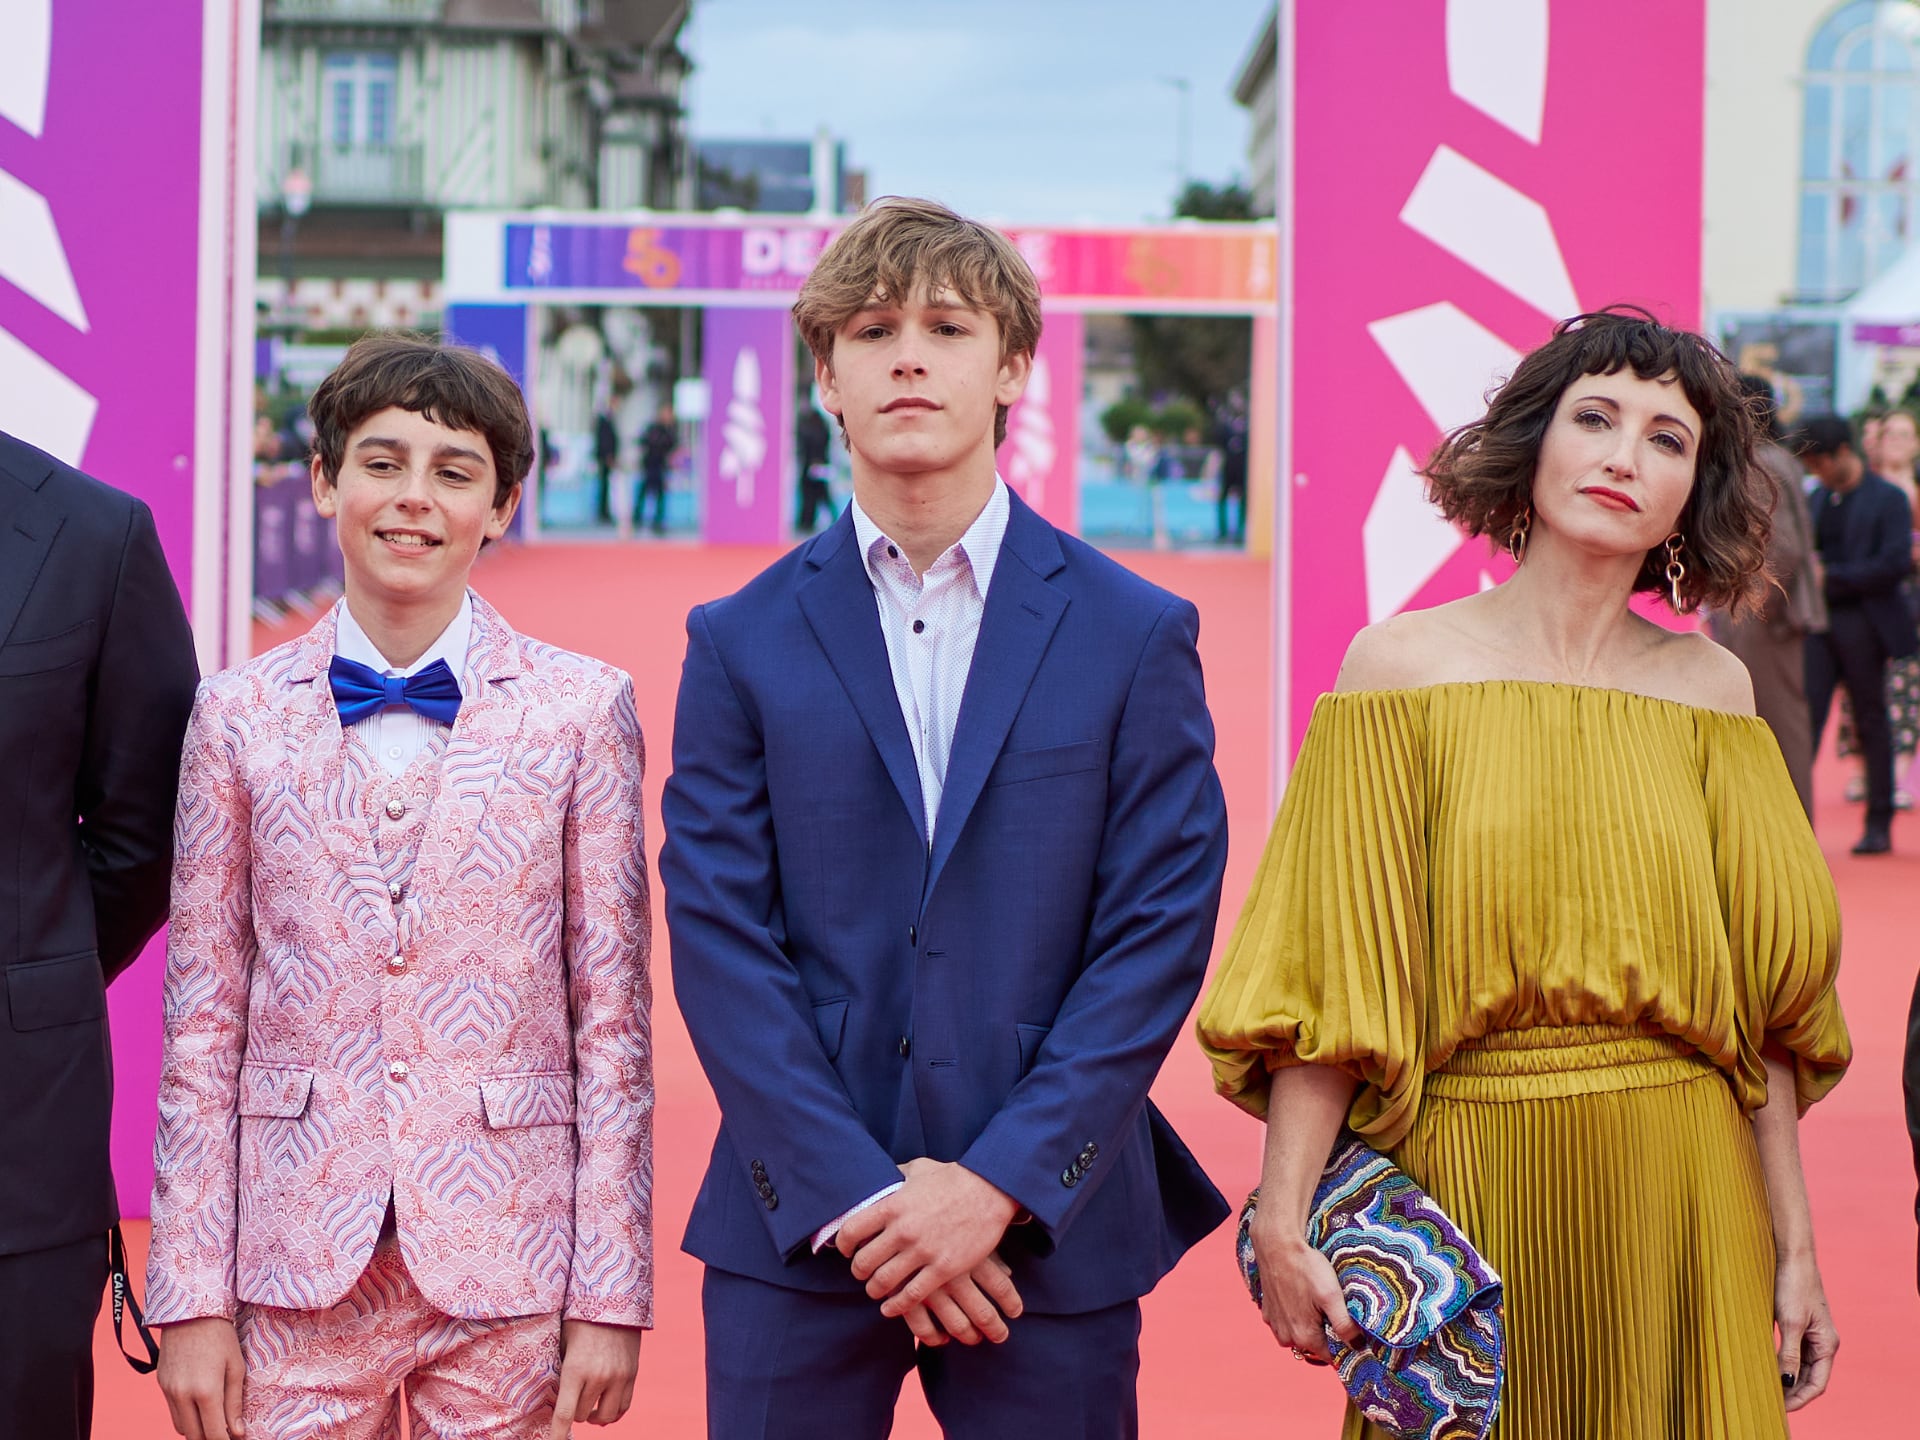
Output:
top-left (1238, 1133), bottom-right (1507, 1440)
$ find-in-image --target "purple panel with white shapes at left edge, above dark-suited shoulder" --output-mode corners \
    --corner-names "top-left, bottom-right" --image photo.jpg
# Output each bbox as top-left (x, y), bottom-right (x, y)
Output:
top-left (0, 0), bottom-right (202, 599)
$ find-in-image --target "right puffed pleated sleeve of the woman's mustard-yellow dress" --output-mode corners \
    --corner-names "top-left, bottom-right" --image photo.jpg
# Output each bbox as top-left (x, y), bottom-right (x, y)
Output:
top-left (1701, 714), bottom-right (1853, 1110)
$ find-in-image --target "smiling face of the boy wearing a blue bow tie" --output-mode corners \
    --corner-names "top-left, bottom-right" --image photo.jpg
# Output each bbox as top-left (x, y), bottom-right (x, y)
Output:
top-left (313, 407), bottom-right (520, 607)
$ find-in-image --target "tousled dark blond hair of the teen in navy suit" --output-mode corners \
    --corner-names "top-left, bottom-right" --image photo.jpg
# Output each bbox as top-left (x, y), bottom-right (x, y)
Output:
top-left (793, 196), bottom-right (1041, 447)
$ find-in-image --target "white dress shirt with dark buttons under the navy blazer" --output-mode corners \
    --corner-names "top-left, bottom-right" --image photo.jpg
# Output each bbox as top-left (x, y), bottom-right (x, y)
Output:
top-left (814, 476), bottom-right (1012, 1252)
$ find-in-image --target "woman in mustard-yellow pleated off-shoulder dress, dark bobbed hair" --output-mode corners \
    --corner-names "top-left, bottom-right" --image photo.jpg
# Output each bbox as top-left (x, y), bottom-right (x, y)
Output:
top-left (1200, 311), bottom-right (1849, 1440)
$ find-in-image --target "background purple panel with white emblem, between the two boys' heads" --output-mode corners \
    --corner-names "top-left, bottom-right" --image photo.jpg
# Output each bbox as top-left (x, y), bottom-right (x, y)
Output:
top-left (701, 309), bottom-right (793, 545)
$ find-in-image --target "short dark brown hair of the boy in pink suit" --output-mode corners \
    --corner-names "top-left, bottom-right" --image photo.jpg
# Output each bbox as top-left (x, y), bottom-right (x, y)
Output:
top-left (307, 330), bottom-right (534, 507)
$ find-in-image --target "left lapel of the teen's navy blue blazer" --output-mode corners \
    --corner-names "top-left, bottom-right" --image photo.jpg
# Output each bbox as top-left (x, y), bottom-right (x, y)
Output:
top-left (799, 526), bottom-right (927, 843)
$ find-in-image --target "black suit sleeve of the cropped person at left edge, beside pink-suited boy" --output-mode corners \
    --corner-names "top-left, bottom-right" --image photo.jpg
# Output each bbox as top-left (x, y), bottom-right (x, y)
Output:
top-left (75, 503), bottom-right (200, 979)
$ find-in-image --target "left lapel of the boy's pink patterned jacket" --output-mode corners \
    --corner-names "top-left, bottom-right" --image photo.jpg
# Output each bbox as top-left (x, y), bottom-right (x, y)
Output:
top-left (284, 601), bottom-right (386, 924)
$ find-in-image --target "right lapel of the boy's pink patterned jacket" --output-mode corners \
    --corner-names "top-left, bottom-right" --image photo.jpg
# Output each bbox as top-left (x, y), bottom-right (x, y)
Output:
top-left (413, 595), bottom-right (528, 902)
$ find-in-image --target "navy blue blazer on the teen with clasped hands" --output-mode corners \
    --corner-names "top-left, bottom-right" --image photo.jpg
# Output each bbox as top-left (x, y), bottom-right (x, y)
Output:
top-left (660, 497), bottom-right (1227, 1313)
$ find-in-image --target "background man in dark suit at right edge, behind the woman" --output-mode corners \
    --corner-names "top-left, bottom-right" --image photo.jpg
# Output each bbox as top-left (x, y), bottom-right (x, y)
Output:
top-left (1801, 415), bottom-right (1920, 854)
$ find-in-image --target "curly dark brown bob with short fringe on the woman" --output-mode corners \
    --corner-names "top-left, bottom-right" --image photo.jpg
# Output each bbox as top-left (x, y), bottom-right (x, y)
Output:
top-left (1421, 305), bottom-right (1772, 614)
